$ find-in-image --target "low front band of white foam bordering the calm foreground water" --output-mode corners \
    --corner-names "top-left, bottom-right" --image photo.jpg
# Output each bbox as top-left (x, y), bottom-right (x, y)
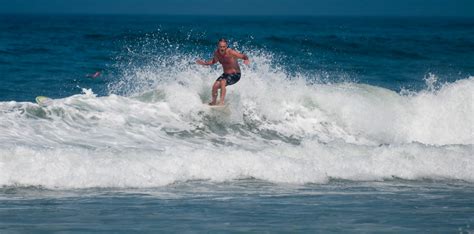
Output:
top-left (0, 141), bottom-right (474, 188)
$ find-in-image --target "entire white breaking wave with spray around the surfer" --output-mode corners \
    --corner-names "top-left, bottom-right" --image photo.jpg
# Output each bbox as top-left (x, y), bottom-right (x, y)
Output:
top-left (0, 48), bottom-right (474, 188)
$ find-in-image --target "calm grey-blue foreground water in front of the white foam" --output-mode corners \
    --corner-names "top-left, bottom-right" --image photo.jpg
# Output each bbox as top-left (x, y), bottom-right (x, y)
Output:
top-left (0, 180), bottom-right (474, 233)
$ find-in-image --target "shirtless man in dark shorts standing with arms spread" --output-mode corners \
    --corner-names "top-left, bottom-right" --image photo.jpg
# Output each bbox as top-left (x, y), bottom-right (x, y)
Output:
top-left (196, 38), bottom-right (250, 106)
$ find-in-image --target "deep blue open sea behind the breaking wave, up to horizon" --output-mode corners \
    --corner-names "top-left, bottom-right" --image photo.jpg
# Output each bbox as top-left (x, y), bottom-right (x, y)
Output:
top-left (0, 15), bottom-right (474, 101)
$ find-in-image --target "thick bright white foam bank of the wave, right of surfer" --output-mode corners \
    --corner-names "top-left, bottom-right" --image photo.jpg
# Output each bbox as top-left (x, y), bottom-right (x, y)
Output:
top-left (315, 77), bottom-right (474, 145)
